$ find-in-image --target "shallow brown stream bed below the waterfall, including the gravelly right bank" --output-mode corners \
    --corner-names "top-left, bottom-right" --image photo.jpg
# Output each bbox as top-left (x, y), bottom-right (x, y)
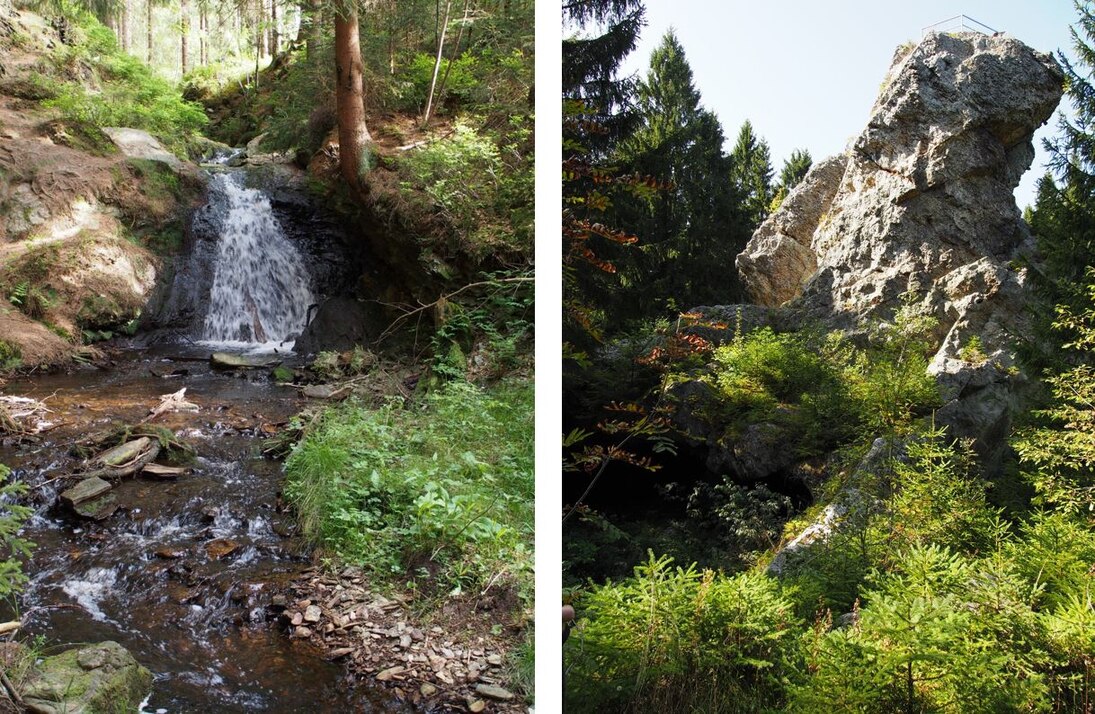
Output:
top-left (0, 344), bottom-right (525, 713)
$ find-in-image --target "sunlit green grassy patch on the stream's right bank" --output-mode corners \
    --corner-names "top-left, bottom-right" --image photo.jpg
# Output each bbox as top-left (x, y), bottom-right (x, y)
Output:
top-left (286, 380), bottom-right (534, 597)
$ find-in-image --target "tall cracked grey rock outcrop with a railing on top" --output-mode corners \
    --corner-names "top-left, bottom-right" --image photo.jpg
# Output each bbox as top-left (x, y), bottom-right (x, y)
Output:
top-left (737, 33), bottom-right (1063, 459)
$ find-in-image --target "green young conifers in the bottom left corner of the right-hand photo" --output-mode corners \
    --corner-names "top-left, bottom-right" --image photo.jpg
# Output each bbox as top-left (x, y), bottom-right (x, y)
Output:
top-left (566, 553), bottom-right (798, 712)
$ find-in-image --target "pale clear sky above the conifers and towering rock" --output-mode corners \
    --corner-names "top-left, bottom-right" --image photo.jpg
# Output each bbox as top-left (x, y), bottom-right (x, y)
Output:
top-left (624, 0), bottom-right (1075, 208)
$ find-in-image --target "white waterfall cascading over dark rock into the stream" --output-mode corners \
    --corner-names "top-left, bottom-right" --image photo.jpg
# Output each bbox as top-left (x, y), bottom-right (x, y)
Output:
top-left (201, 173), bottom-right (314, 348)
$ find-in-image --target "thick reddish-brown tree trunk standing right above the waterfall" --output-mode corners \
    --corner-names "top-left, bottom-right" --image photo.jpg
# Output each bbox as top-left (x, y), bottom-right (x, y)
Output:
top-left (335, 0), bottom-right (372, 188)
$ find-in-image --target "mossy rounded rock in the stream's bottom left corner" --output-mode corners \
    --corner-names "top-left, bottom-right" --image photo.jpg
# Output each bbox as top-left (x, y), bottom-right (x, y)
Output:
top-left (23, 642), bottom-right (152, 714)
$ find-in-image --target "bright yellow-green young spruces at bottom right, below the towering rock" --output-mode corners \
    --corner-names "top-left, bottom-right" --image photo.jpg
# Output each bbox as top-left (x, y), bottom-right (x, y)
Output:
top-left (789, 545), bottom-right (1051, 714)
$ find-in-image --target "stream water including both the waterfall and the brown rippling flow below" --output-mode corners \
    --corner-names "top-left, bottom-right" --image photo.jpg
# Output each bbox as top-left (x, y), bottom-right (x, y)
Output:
top-left (0, 163), bottom-right (404, 713)
